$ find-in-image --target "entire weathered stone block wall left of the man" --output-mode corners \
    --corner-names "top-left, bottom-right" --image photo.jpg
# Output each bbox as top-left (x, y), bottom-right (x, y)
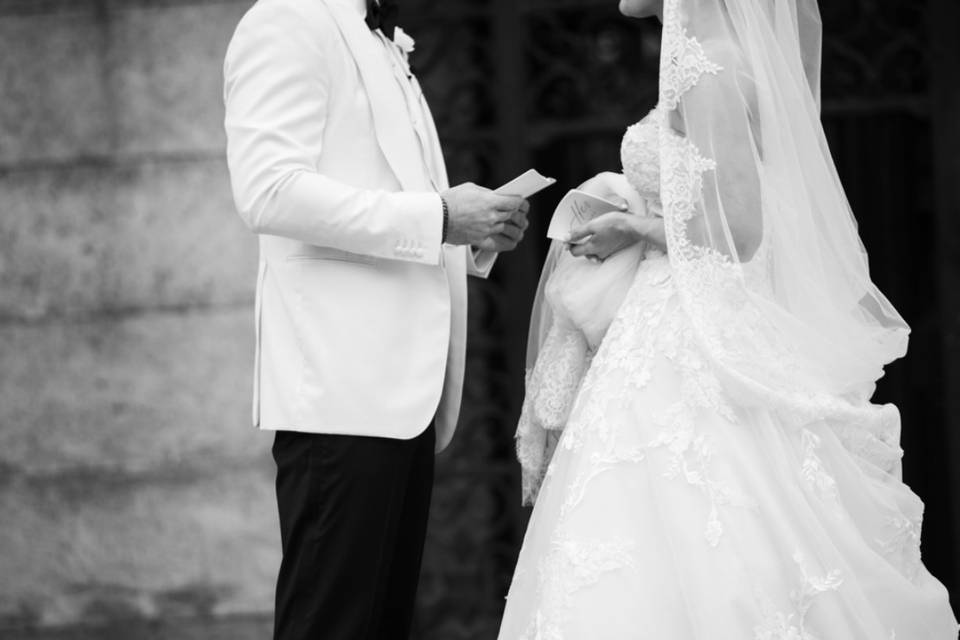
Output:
top-left (0, 0), bottom-right (279, 637)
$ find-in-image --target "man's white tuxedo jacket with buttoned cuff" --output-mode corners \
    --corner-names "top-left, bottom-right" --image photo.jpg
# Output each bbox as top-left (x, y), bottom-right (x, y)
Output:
top-left (224, 0), bottom-right (492, 451)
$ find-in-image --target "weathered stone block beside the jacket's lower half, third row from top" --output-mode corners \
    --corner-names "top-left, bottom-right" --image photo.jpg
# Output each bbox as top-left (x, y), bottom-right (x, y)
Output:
top-left (0, 307), bottom-right (269, 476)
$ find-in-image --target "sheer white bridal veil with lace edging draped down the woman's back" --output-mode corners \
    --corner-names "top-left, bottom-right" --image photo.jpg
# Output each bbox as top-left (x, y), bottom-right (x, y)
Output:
top-left (657, 0), bottom-right (909, 418)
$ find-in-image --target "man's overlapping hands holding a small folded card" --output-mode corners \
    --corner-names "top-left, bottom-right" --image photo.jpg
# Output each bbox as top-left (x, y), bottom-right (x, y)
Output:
top-left (440, 182), bottom-right (530, 252)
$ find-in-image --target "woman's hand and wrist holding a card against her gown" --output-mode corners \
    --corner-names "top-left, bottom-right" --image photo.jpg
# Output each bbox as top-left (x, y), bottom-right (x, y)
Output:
top-left (568, 211), bottom-right (667, 262)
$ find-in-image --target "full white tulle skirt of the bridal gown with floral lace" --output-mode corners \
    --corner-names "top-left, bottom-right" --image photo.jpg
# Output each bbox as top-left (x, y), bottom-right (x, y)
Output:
top-left (499, 257), bottom-right (957, 640)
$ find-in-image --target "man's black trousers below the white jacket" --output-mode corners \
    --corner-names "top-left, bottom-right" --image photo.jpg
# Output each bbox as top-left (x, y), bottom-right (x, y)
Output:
top-left (273, 426), bottom-right (436, 640)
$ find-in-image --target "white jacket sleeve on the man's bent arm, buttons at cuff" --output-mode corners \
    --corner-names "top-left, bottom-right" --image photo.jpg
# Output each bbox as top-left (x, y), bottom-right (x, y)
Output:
top-left (224, 2), bottom-right (443, 265)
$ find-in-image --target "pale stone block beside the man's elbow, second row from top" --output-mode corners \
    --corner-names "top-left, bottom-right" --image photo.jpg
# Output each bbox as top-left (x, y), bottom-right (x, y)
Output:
top-left (101, 160), bottom-right (257, 307)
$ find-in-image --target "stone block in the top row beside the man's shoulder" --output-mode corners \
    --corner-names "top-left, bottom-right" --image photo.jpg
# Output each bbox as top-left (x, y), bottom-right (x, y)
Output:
top-left (111, 2), bottom-right (248, 153)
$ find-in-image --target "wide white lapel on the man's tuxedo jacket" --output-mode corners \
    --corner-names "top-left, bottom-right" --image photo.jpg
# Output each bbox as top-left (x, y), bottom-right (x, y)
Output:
top-left (324, 0), bottom-right (424, 191)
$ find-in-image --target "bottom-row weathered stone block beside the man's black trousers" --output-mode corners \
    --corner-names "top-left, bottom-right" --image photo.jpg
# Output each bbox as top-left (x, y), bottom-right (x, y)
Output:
top-left (0, 463), bottom-right (280, 628)
